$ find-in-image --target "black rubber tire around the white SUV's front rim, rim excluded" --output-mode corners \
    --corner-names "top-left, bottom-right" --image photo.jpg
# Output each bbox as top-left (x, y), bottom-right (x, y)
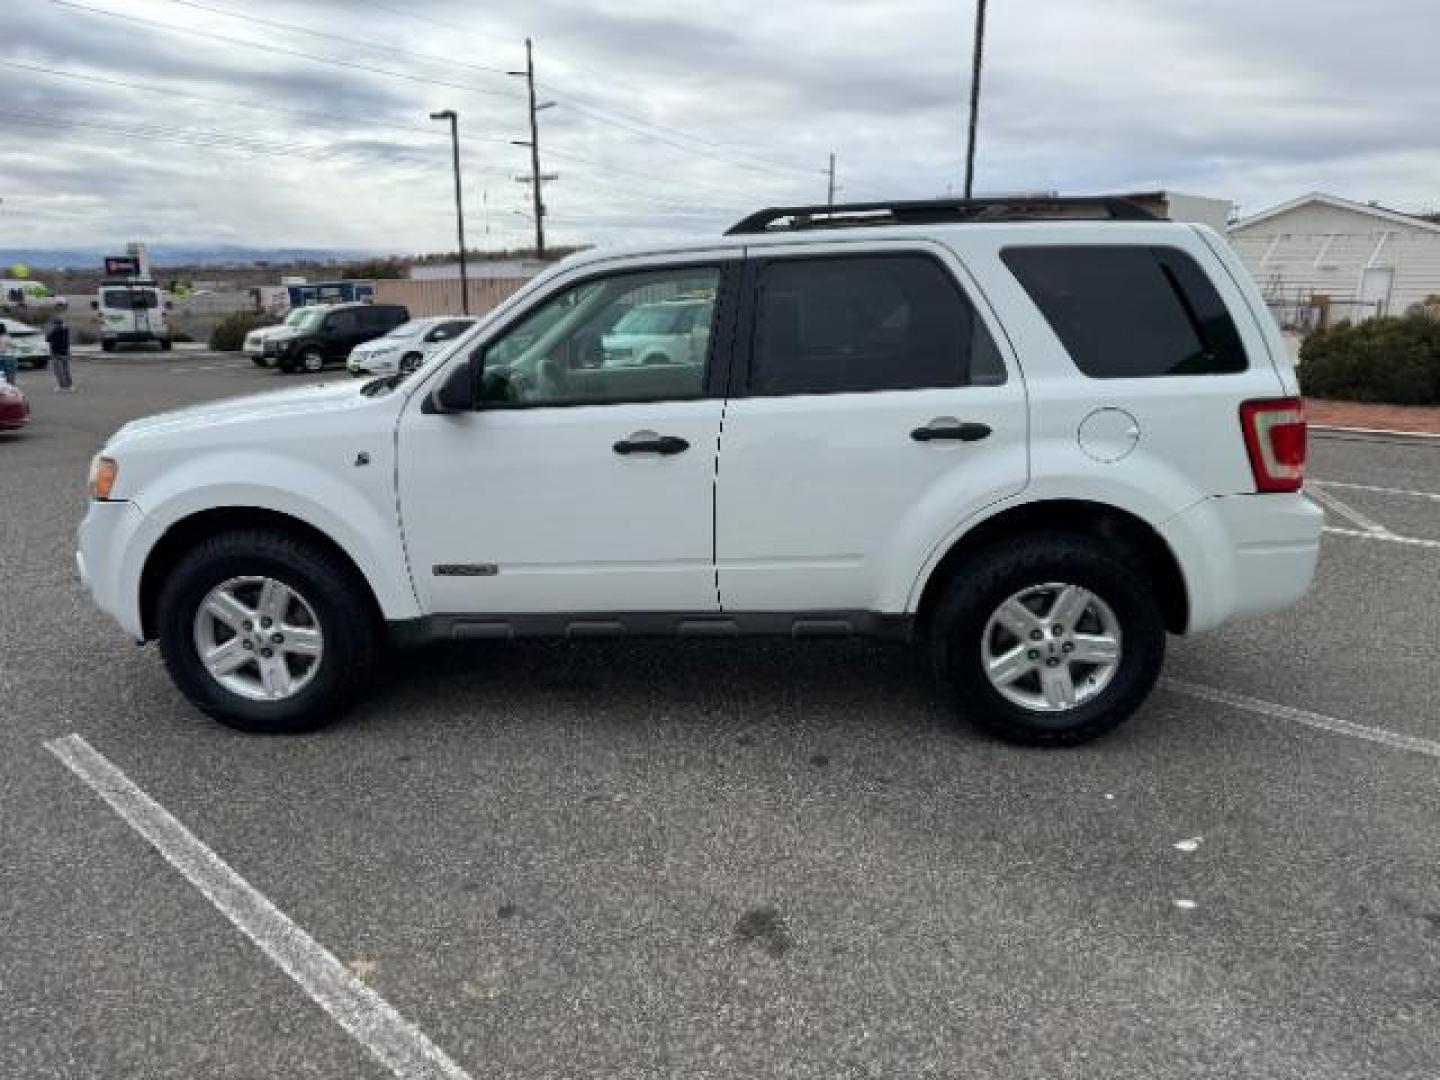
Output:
top-left (157, 528), bottom-right (380, 734)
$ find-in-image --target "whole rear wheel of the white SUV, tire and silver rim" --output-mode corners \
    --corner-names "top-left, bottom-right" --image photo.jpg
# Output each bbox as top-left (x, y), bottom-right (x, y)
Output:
top-left (932, 534), bottom-right (1165, 746)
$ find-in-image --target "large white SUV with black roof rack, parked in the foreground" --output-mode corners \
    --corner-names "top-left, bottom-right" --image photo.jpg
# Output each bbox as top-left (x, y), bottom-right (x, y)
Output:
top-left (79, 200), bottom-right (1322, 746)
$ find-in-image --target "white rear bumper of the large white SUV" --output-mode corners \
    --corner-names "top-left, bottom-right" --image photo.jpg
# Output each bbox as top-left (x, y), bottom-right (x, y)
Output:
top-left (1159, 494), bottom-right (1325, 634)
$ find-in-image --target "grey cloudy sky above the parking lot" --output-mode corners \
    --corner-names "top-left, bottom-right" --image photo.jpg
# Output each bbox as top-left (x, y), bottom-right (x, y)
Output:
top-left (0, 0), bottom-right (1440, 258)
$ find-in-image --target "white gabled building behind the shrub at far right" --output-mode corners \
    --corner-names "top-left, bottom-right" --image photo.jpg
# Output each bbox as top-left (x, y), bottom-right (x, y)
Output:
top-left (1230, 192), bottom-right (1440, 328)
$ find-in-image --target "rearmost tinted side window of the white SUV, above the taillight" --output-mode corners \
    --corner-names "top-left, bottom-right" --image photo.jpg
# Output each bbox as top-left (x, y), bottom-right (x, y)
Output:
top-left (1001, 245), bottom-right (1248, 379)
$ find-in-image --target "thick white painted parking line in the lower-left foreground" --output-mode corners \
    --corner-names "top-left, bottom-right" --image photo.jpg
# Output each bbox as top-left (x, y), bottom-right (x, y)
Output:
top-left (45, 734), bottom-right (469, 1080)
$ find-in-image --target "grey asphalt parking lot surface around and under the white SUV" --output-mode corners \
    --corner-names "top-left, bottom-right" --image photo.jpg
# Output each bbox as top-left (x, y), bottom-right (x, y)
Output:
top-left (0, 353), bottom-right (1440, 1080)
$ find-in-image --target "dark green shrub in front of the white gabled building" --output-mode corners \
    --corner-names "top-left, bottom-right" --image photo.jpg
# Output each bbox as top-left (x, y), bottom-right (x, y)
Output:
top-left (1300, 318), bottom-right (1440, 405)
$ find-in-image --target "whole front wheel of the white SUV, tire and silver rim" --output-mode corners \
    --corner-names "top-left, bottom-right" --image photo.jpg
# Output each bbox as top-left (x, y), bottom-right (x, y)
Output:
top-left (158, 530), bottom-right (379, 734)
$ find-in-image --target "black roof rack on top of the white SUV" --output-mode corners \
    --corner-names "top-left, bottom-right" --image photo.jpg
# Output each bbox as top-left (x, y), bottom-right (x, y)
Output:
top-left (726, 196), bottom-right (1165, 236)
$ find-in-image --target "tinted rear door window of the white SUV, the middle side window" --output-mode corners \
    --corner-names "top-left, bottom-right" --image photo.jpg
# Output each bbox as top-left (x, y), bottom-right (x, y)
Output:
top-left (750, 255), bottom-right (1005, 395)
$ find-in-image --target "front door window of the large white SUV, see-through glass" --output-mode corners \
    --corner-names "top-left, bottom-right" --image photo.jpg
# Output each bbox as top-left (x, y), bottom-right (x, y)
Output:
top-left (481, 266), bottom-right (720, 408)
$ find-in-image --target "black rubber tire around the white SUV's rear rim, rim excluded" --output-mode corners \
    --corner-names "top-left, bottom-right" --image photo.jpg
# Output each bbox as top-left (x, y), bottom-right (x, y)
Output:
top-left (929, 533), bottom-right (1165, 747)
